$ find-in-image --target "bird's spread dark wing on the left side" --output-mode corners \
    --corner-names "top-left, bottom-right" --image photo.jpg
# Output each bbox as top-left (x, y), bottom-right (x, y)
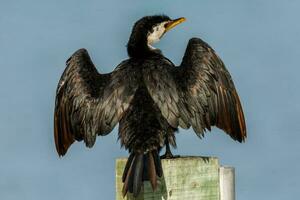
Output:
top-left (54, 49), bottom-right (137, 155)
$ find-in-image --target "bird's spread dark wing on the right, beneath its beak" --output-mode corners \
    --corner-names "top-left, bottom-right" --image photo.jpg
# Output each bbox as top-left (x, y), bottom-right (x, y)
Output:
top-left (144, 38), bottom-right (246, 142)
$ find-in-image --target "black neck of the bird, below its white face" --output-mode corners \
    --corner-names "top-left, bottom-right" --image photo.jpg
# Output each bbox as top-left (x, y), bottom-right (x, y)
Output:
top-left (127, 35), bottom-right (161, 58)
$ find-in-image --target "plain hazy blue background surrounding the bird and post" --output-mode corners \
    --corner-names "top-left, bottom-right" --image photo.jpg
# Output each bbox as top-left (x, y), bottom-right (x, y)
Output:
top-left (0, 0), bottom-right (300, 200)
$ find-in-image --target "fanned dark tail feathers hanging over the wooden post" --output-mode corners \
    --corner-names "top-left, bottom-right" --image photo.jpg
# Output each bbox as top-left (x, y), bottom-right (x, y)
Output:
top-left (122, 150), bottom-right (162, 197)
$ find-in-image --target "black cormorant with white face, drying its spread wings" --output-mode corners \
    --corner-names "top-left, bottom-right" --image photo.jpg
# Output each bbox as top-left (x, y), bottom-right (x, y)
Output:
top-left (54, 15), bottom-right (247, 197)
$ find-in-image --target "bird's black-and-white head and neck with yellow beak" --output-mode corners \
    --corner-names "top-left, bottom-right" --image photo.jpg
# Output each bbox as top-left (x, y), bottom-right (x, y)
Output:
top-left (127, 15), bottom-right (185, 57)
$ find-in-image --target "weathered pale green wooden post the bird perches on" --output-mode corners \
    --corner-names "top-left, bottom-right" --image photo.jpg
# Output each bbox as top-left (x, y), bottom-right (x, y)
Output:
top-left (116, 157), bottom-right (220, 200)
